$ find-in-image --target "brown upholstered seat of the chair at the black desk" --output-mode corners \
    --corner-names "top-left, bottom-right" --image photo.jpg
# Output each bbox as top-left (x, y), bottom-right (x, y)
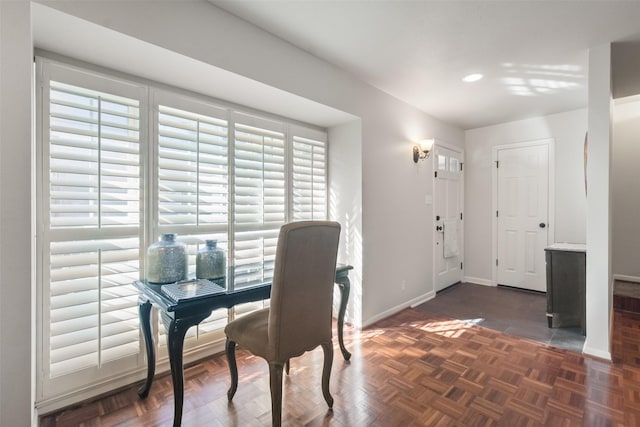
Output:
top-left (224, 308), bottom-right (269, 359)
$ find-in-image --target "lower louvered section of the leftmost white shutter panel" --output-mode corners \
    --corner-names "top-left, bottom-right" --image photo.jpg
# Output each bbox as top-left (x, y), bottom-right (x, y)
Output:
top-left (49, 238), bottom-right (139, 378)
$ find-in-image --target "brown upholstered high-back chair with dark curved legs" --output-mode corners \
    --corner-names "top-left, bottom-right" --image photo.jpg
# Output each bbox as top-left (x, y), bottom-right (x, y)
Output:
top-left (224, 221), bottom-right (340, 427)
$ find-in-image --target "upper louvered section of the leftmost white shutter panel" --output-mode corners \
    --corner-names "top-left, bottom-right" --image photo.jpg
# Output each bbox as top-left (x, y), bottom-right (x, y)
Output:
top-left (49, 81), bottom-right (140, 229)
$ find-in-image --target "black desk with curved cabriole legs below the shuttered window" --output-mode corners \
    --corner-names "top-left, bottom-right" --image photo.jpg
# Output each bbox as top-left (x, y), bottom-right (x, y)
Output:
top-left (133, 265), bottom-right (353, 427)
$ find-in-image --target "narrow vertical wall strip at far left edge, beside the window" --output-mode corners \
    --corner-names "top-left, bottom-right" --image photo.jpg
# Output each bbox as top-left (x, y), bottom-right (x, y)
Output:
top-left (0, 1), bottom-right (34, 427)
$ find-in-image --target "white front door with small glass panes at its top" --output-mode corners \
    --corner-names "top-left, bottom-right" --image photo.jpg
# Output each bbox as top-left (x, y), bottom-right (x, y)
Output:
top-left (433, 146), bottom-right (463, 291)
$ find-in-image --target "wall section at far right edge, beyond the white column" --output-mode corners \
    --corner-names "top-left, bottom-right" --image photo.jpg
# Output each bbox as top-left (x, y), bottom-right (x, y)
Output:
top-left (611, 95), bottom-right (640, 278)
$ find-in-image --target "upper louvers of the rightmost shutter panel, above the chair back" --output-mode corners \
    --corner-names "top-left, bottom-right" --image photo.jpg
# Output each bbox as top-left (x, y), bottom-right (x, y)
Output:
top-left (291, 126), bottom-right (327, 221)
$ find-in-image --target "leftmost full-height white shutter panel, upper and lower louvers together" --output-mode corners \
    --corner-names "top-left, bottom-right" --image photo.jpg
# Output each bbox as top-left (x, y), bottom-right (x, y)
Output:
top-left (38, 64), bottom-right (144, 388)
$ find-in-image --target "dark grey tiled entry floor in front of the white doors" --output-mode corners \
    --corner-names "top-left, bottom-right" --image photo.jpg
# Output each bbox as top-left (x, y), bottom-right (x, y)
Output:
top-left (416, 283), bottom-right (585, 353)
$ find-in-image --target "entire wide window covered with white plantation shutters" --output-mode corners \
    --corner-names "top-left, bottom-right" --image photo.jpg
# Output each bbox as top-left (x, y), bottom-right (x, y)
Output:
top-left (36, 59), bottom-right (327, 400)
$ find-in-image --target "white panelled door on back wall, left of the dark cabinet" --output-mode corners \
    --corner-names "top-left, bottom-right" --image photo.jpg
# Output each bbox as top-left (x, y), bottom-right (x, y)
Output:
top-left (496, 144), bottom-right (549, 291)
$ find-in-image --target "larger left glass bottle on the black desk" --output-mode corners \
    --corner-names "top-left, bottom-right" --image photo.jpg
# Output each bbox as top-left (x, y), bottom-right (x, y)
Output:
top-left (147, 233), bottom-right (188, 283)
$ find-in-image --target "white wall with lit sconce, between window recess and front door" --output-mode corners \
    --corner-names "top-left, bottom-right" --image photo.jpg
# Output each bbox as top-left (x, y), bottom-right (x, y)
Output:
top-left (362, 96), bottom-right (463, 325)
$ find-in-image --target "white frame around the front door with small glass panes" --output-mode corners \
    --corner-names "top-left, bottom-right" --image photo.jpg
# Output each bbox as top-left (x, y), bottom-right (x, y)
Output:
top-left (431, 139), bottom-right (465, 294)
